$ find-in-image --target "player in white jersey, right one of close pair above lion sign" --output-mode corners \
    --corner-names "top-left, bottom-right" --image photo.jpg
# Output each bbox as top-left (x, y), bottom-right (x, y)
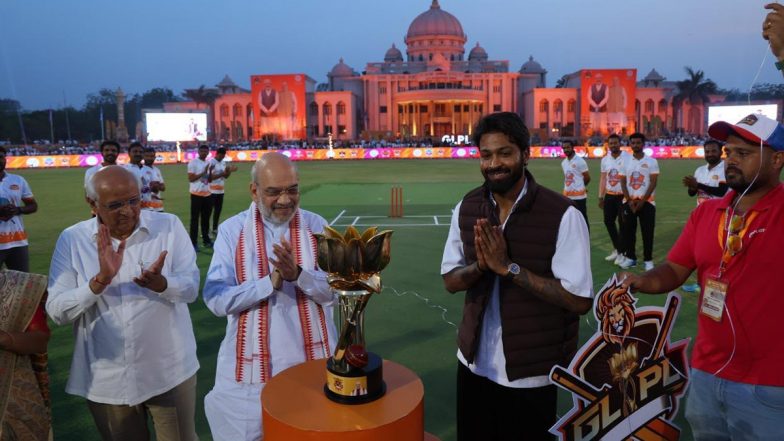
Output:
top-left (618, 133), bottom-right (659, 271)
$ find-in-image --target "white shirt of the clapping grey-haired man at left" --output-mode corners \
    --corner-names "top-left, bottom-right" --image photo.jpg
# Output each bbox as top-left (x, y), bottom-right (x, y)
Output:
top-left (46, 210), bottom-right (199, 406)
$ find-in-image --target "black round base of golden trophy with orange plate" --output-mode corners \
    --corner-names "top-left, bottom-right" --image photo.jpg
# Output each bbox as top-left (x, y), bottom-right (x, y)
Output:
top-left (324, 352), bottom-right (387, 404)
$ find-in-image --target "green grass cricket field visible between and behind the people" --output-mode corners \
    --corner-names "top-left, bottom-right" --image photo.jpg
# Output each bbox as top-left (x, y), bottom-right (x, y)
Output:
top-left (13, 159), bottom-right (702, 441)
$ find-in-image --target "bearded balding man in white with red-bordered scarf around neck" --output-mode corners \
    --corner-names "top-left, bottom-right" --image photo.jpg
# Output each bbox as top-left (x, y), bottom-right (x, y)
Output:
top-left (204, 153), bottom-right (336, 441)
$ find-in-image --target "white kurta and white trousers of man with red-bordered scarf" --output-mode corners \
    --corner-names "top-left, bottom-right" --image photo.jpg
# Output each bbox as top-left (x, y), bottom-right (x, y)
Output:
top-left (204, 209), bottom-right (337, 440)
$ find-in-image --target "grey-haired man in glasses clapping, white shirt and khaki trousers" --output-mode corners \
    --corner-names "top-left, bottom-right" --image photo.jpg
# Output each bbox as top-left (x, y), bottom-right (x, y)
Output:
top-left (46, 166), bottom-right (199, 440)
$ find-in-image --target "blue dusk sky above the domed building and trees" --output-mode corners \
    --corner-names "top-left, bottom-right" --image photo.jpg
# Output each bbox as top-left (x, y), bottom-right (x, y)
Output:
top-left (0, 0), bottom-right (782, 110)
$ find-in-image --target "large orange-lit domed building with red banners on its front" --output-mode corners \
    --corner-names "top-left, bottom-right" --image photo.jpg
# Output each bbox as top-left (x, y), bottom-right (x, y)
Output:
top-left (173, 0), bottom-right (721, 142)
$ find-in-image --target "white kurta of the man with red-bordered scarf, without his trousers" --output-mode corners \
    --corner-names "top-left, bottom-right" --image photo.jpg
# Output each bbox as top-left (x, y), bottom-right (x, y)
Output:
top-left (203, 209), bottom-right (337, 384)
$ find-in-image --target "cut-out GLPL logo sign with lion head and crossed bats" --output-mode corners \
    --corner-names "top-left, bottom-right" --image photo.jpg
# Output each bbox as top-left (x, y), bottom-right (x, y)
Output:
top-left (550, 275), bottom-right (689, 441)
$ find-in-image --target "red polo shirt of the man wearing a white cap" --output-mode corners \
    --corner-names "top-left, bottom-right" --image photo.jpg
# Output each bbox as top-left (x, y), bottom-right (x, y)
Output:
top-left (667, 184), bottom-right (784, 386)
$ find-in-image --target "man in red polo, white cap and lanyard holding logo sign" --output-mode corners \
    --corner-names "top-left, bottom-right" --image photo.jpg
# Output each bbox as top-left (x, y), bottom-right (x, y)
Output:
top-left (622, 115), bottom-right (784, 441)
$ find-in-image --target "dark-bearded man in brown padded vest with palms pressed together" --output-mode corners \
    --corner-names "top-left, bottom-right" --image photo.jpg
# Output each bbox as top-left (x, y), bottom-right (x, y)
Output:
top-left (441, 112), bottom-right (593, 441)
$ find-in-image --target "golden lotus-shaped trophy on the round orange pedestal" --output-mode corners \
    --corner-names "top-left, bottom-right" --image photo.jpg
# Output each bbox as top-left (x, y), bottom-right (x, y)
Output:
top-left (316, 226), bottom-right (392, 404)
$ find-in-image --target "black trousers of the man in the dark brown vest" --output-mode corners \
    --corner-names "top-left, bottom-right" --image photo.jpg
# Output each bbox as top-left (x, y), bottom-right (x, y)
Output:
top-left (457, 362), bottom-right (558, 441)
